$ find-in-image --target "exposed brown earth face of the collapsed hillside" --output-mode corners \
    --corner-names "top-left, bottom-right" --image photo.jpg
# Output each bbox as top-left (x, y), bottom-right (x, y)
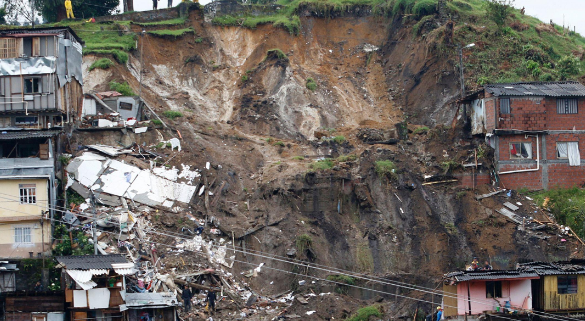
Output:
top-left (82, 7), bottom-right (575, 309)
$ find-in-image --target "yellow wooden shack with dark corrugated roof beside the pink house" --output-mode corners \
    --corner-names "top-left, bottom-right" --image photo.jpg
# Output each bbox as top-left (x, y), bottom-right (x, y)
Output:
top-left (519, 260), bottom-right (585, 312)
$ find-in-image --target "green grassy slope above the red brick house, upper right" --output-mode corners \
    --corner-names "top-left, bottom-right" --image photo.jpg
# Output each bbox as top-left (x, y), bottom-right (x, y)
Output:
top-left (442, 0), bottom-right (585, 85)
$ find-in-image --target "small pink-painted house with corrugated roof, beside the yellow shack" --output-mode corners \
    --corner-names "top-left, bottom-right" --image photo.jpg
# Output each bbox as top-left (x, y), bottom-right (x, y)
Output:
top-left (443, 271), bottom-right (539, 317)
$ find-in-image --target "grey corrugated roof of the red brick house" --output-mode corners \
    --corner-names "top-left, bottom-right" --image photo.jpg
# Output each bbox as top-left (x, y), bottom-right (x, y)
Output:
top-left (485, 81), bottom-right (585, 97)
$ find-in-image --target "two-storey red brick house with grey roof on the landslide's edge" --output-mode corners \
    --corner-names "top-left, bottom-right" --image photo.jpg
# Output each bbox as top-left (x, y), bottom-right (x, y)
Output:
top-left (462, 81), bottom-right (585, 190)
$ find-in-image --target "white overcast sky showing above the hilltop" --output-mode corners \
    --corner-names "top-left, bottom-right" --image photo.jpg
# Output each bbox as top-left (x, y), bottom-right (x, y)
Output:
top-left (120, 0), bottom-right (585, 35)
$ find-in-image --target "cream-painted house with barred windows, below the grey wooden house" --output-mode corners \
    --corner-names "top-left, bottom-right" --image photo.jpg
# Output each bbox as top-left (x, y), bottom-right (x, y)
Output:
top-left (0, 130), bottom-right (59, 258)
